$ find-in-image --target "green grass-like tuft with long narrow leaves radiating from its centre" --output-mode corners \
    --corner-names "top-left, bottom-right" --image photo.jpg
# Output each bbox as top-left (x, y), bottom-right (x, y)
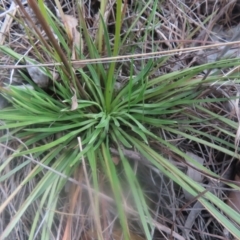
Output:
top-left (0, 0), bottom-right (240, 240)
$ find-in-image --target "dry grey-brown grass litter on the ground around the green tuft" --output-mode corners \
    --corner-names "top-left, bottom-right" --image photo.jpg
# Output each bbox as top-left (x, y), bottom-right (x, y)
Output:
top-left (0, 0), bottom-right (240, 240)
